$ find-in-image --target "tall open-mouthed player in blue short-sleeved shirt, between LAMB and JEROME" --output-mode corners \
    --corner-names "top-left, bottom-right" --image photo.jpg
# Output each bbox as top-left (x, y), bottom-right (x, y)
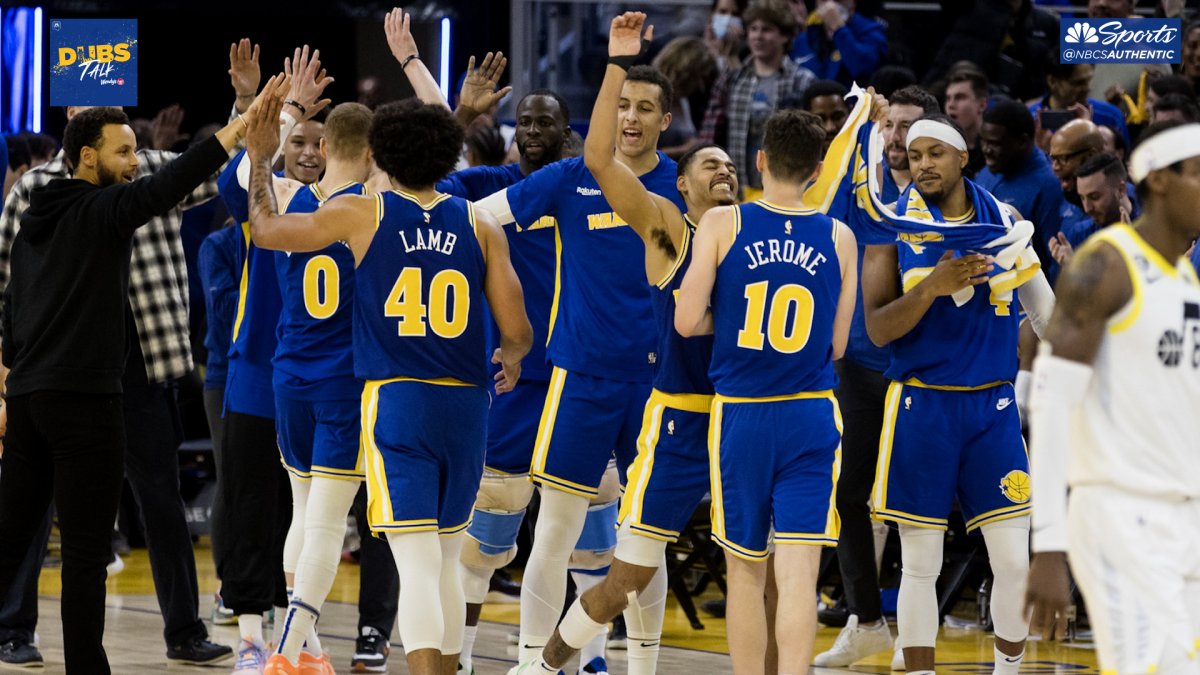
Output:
top-left (479, 59), bottom-right (686, 663)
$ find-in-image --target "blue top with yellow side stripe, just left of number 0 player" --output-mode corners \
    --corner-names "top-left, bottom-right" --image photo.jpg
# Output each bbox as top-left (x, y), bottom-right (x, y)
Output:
top-left (217, 150), bottom-right (283, 419)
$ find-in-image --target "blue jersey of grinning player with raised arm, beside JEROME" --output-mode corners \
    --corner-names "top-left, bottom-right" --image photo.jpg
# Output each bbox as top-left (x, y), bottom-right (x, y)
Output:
top-left (650, 216), bottom-right (713, 395)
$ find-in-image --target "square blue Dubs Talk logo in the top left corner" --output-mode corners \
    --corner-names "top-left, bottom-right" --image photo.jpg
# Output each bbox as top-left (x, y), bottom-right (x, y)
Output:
top-left (50, 19), bottom-right (138, 106)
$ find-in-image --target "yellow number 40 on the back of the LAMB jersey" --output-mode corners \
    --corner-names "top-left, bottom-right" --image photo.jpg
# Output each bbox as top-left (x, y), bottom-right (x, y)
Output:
top-left (383, 267), bottom-right (470, 339)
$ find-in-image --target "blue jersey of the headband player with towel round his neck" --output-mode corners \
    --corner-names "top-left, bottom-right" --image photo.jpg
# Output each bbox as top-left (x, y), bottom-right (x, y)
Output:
top-left (886, 213), bottom-right (1020, 387)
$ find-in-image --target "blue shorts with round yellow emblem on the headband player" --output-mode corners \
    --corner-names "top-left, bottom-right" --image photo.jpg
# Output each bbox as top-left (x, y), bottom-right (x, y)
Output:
top-left (871, 382), bottom-right (1030, 532)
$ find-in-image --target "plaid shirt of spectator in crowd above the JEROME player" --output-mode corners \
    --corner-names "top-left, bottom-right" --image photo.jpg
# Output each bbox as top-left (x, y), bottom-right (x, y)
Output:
top-left (700, 55), bottom-right (816, 183)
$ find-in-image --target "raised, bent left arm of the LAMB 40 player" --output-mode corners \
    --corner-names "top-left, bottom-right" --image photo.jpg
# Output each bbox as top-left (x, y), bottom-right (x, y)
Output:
top-left (246, 89), bottom-right (376, 254)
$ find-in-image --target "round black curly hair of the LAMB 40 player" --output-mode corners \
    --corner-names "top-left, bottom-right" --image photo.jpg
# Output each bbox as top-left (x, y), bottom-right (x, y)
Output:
top-left (371, 98), bottom-right (463, 189)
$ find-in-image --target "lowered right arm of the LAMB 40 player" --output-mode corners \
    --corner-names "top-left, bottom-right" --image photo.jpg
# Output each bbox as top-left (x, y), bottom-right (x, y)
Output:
top-left (475, 209), bottom-right (533, 394)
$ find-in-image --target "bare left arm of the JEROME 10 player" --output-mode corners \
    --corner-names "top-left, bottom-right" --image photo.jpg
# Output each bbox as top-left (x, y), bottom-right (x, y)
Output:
top-left (676, 201), bottom-right (733, 338)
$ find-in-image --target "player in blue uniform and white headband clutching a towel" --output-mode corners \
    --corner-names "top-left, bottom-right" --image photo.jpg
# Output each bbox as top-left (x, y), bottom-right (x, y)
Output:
top-left (863, 114), bottom-right (1052, 675)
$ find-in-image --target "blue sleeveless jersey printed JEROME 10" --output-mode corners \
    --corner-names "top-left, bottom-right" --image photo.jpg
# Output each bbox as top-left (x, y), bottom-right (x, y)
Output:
top-left (709, 201), bottom-right (841, 399)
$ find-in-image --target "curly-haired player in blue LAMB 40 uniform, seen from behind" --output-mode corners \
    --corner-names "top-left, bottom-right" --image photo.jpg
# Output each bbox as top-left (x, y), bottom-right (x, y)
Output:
top-left (248, 91), bottom-right (533, 674)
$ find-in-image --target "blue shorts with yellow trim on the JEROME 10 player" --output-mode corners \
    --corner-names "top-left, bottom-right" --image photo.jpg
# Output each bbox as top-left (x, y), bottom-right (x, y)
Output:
top-left (708, 390), bottom-right (841, 561)
